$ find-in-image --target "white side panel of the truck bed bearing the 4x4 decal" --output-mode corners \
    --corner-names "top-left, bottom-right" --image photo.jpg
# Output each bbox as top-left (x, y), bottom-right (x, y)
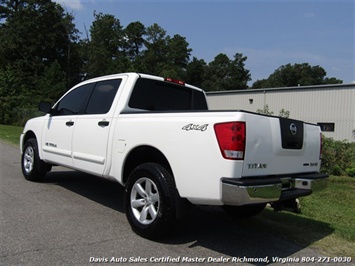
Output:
top-left (110, 113), bottom-right (246, 204)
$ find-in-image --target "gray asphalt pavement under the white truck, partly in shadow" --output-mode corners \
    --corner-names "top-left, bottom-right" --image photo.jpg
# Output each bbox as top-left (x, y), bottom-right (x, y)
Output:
top-left (0, 141), bottom-right (329, 265)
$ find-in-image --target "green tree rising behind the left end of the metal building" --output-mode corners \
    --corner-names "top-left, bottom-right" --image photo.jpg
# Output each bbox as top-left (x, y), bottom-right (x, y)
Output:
top-left (202, 53), bottom-right (251, 91)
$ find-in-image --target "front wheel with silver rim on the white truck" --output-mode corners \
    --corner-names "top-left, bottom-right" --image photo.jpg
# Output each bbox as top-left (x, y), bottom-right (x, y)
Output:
top-left (21, 138), bottom-right (52, 181)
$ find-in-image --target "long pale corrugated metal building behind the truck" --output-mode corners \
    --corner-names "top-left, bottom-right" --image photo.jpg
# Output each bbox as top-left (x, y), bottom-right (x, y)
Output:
top-left (207, 84), bottom-right (355, 142)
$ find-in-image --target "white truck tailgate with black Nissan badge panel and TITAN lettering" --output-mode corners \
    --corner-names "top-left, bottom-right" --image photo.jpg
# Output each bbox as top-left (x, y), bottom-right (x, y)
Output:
top-left (242, 113), bottom-right (321, 177)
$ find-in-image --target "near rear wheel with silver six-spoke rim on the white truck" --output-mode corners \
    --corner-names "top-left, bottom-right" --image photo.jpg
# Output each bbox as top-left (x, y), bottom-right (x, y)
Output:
top-left (124, 163), bottom-right (177, 240)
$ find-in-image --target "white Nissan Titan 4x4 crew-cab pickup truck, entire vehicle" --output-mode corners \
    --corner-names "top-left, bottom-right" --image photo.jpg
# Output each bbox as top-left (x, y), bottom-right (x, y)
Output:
top-left (20, 73), bottom-right (327, 239)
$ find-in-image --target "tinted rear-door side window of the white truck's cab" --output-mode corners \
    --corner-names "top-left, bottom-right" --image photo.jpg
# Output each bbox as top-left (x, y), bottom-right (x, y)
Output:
top-left (85, 79), bottom-right (121, 114)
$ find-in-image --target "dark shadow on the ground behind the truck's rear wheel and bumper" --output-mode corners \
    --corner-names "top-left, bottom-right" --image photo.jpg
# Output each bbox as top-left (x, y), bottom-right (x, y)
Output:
top-left (169, 206), bottom-right (334, 260)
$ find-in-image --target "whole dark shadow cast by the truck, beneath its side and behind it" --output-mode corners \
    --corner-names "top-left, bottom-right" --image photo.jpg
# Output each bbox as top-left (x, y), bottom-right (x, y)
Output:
top-left (43, 169), bottom-right (334, 262)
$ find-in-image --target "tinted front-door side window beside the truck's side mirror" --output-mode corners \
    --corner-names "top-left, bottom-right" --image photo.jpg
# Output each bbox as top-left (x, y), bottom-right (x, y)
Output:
top-left (55, 83), bottom-right (94, 115)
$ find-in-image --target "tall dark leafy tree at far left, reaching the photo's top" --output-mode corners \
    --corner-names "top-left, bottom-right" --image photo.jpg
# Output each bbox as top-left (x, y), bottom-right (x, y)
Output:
top-left (0, 0), bottom-right (79, 123)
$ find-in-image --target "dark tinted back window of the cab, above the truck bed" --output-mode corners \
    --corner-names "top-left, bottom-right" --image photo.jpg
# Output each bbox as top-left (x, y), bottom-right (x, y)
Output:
top-left (128, 78), bottom-right (207, 111)
